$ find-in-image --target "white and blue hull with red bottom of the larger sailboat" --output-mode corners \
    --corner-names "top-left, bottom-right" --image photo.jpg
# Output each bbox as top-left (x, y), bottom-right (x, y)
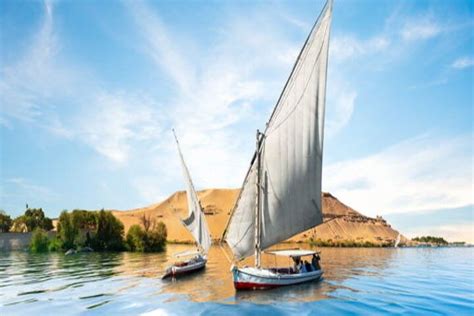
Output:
top-left (232, 267), bottom-right (323, 290)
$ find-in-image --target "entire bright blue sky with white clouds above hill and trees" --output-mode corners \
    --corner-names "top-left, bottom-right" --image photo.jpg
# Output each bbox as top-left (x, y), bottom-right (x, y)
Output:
top-left (0, 0), bottom-right (474, 242)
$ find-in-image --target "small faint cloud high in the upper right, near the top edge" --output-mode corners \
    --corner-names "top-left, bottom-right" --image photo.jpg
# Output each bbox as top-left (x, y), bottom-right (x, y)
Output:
top-left (401, 16), bottom-right (443, 41)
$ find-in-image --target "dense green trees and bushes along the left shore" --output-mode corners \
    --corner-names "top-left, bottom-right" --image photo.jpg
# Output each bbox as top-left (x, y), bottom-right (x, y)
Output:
top-left (0, 208), bottom-right (167, 253)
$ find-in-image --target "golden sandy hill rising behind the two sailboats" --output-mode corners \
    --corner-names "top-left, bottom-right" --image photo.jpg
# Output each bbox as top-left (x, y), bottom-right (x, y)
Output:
top-left (113, 189), bottom-right (404, 243)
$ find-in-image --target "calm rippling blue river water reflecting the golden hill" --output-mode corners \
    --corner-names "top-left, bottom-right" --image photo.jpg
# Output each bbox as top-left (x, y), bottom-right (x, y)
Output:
top-left (0, 245), bottom-right (474, 315)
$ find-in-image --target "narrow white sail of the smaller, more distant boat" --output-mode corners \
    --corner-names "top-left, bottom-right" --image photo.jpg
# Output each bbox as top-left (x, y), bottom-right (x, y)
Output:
top-left (173, 130), bottom-right (211, 254)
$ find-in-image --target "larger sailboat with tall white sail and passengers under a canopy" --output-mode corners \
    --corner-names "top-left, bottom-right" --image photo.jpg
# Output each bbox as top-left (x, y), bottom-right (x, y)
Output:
top-left (222, 0), bottom-right (332, 290)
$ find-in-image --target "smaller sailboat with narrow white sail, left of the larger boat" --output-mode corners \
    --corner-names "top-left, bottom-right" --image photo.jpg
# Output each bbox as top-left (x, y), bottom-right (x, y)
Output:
top-left (162, 130), bottom-right (211, 279)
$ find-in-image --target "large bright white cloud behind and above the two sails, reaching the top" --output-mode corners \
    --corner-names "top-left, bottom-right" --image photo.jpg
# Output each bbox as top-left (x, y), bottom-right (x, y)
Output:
top-left (127, 2), bottom-right (304, 191)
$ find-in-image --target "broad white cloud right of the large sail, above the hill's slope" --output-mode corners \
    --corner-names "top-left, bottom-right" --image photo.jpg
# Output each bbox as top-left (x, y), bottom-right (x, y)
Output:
top-left (323, 135), bottom-right (474, 216)
